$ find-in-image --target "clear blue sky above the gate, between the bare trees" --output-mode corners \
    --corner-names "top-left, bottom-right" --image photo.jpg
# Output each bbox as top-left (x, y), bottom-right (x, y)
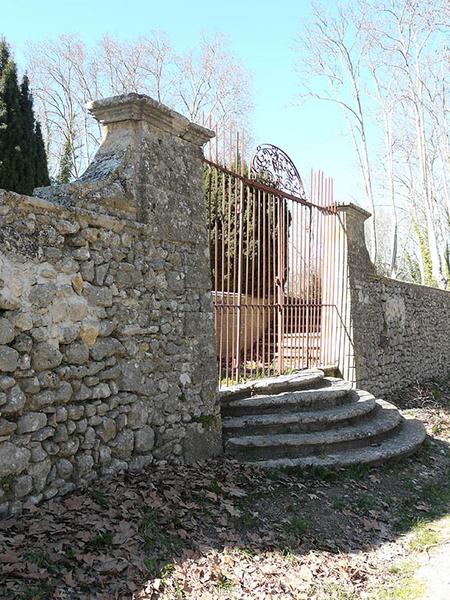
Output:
top-left (0, 0), bottom-right (362, 202)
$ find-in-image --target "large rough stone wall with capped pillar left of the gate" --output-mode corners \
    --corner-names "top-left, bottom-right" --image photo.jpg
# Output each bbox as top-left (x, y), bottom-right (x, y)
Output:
top-left (0, 94), bottom-right (221, 514)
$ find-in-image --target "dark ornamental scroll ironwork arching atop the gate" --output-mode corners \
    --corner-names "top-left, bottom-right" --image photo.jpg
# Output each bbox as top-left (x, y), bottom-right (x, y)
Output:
top-left (250, 144), bottom-right (305, 198)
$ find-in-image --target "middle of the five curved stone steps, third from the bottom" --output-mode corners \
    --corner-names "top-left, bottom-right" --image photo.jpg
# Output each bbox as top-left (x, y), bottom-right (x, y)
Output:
top-left (222, 390), bottom-right (376, 437)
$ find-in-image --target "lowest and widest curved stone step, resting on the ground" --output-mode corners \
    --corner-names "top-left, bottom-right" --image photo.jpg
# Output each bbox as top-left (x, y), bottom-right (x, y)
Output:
top-left (247, 419), bottom-right (426, 469)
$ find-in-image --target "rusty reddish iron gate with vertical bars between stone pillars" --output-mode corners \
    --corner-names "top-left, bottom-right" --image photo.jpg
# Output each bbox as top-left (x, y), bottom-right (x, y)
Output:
top-left (204, 130), bottom-right (348, 385)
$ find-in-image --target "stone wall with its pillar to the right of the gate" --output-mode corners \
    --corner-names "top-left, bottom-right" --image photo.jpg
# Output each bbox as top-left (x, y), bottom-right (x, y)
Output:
top-left (330, 205), bottom-right (450, 397)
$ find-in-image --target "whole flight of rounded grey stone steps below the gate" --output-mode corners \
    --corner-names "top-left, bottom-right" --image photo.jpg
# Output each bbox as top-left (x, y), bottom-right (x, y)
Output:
top-left (222, 369), bottom-right (425, 468)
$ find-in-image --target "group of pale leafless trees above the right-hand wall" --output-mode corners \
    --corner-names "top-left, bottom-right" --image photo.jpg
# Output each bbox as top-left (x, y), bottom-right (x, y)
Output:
top-left (300, 0), bottom-right (450, 288)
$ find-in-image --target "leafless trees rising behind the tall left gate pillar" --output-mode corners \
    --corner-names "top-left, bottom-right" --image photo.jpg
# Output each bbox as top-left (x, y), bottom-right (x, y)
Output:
top-left (28, 32), bottom-right (251, 177)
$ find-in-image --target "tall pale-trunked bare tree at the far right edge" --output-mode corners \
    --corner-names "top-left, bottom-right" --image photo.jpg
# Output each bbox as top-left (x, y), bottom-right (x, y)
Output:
top-left (372, 0), bottom-right (448, 287)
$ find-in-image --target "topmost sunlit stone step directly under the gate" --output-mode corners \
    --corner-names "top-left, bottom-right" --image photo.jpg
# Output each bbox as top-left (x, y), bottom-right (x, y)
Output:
top-left (219, 369), bottom-right (324, 401)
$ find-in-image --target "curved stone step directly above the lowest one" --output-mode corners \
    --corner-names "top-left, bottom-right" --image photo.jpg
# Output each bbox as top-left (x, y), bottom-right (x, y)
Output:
top-left (225, 400), bottom-right (403, 461)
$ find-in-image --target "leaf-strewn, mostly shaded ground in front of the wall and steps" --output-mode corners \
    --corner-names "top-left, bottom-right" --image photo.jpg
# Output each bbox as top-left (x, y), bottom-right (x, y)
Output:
top-left (0, 382), bottom-right (450, 600)
